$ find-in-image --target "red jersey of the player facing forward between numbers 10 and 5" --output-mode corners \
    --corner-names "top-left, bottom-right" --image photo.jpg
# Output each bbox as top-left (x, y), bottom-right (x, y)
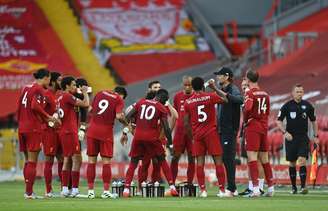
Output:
top-left (173, 91), bottom-right (192, 131)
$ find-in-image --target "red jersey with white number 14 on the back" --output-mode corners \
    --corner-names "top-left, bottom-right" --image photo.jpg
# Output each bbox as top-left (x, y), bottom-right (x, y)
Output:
top-left (244, 88), bottom-right (270, 133)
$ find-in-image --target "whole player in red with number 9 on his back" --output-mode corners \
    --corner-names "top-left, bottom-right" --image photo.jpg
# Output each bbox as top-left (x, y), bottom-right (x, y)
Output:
top-left (87, 86), bottom-right (127, 198)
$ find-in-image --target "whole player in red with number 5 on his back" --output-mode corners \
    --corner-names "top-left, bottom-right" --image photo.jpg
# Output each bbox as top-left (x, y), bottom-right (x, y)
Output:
top-left (184, 77), bottom-right (228, 197)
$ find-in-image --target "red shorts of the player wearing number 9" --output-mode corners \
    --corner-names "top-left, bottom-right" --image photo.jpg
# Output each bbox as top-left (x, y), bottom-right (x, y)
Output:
top-left (87, 137), bottom-right (114, 158)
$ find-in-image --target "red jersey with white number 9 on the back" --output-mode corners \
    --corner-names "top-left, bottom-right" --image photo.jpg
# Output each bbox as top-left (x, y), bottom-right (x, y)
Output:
top-left (87, 91), bottom-right (124, 140)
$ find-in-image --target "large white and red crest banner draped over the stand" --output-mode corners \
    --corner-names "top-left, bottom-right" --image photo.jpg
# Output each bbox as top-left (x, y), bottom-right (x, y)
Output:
top-left (71, 0), bottom-right (215, 84)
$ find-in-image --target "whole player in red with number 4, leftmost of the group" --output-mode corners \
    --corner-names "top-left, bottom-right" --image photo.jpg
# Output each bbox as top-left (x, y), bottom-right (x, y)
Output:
top-left (17, 69), bottom-right (57, 199)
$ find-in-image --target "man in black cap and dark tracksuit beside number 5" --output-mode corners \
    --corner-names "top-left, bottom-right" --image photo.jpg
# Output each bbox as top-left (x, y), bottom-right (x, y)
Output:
top-left (214, 67), bottom-right (244, 196)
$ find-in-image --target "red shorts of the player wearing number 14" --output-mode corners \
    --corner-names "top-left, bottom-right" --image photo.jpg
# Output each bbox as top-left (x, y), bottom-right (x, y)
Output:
top-left (245, 130), bottom-right (269, 152)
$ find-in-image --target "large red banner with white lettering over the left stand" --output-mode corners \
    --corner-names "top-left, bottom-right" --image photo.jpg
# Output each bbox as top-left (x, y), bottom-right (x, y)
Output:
top-left (0, 0), bottom-right (80, 117)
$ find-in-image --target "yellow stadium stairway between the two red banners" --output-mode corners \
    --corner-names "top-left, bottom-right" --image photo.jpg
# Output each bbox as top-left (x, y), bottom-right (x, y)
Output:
top-left (37, 0), bottom-right (115, 91)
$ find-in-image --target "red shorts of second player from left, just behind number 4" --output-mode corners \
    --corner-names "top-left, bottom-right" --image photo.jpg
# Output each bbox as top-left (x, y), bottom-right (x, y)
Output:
top-left (42, 128), bottom-right (62, 156)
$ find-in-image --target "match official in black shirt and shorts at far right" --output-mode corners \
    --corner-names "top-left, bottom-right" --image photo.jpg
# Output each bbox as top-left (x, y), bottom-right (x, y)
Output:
top-left (277, 84), bottom-right (318, 194)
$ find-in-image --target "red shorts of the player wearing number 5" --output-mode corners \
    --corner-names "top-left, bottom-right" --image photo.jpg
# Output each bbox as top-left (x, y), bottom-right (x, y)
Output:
top-left (193, 130), bottom-right (222, 156)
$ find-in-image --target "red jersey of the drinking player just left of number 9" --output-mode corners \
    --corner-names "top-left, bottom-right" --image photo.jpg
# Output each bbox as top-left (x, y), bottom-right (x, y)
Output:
top-left (57, 92), bottom-right (78, 133)
